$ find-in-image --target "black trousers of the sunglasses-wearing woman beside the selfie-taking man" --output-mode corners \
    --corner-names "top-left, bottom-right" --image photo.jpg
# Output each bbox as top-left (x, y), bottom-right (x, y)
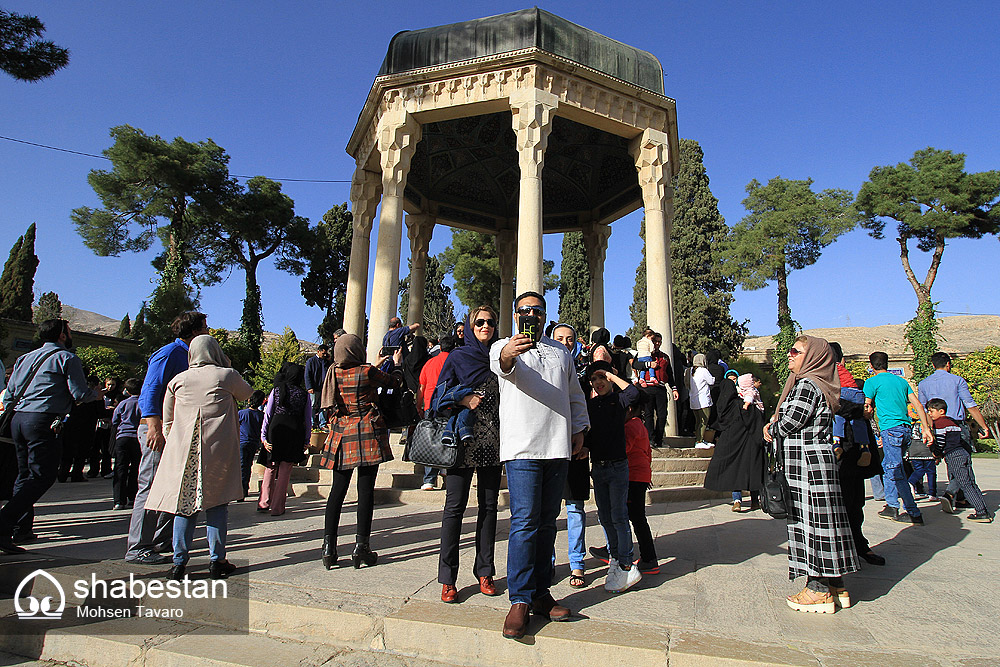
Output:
top-left (438, 466), bottom-right (503, 586)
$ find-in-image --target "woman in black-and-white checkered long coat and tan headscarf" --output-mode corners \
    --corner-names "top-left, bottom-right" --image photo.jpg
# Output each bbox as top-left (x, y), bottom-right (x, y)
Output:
top-left (764, 336), bottom-right (858, 614)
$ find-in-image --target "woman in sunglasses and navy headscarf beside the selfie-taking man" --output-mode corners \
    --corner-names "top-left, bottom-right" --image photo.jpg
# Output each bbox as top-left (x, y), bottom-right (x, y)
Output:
top-left (435, 306), bottom-right (502, 602)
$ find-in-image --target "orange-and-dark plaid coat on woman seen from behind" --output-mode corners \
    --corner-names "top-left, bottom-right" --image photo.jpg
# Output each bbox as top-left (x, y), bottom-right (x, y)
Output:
top-left (320, 364), bottom-right (402, 470)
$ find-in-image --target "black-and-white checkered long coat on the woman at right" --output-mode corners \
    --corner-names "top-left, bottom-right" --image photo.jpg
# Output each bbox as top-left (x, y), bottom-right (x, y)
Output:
top-left (771, 379), bottom-right (858, 579)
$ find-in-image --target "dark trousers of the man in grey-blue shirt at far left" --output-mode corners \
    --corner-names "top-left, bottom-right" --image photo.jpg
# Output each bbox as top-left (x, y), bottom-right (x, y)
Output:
top-left (0, 412), bottom-right (62, 536)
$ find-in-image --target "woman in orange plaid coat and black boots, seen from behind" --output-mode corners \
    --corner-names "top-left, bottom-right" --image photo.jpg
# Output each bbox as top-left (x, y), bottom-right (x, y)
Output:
top-left (320, 334), bottom-right (403, 570)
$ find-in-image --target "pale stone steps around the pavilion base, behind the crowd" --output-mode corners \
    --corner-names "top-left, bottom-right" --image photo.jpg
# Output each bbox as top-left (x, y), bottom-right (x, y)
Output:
top-left (268, 433), bottom-right (729, 508)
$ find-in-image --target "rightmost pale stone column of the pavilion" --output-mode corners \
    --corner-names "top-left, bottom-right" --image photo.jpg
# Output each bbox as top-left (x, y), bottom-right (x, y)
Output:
top-left (630, 129), bottom-right (677, 435)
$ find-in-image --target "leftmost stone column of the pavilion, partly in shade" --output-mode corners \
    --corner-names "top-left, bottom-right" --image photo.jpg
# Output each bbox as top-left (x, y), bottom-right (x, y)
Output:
top-left (344, 166), bottom-right (382, 339)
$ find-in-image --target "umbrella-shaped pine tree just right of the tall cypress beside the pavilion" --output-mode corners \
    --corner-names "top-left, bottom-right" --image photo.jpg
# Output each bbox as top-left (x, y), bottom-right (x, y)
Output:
top-left (726, 176), bottom-right (858, 344)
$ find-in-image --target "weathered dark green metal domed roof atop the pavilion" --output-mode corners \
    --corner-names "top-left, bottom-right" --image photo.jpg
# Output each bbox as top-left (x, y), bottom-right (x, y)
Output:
top-left (379, 7), bottom-right (663, 95)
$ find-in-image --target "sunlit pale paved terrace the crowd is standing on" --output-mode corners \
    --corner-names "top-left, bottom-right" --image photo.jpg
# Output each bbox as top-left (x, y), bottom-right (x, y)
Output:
top-left (0, 459), bottom-right (1000, 665)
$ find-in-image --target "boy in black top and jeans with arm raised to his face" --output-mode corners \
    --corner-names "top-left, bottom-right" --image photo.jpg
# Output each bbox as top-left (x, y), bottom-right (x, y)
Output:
top-left (585, 361), bottom-right (642, 593)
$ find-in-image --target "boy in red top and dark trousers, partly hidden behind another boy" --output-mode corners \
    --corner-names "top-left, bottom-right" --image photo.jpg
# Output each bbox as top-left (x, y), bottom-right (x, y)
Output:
top-left (625, 394), bottom-right (660, 574)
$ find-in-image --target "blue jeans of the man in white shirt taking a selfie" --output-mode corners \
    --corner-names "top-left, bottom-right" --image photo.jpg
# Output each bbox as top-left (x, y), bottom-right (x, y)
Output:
top-left (504, 459), bottom-right (569, 604)
